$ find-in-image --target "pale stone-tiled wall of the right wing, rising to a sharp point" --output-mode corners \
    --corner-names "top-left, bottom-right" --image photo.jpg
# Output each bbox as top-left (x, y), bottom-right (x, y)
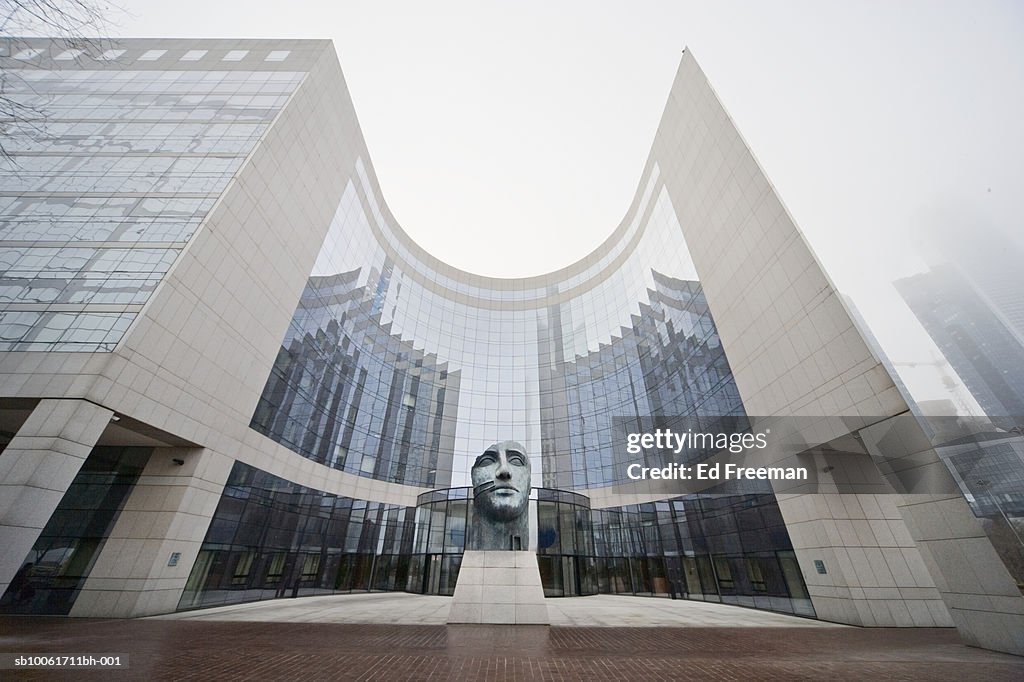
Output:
top-left (649, 52), bottom-right (1024, 652)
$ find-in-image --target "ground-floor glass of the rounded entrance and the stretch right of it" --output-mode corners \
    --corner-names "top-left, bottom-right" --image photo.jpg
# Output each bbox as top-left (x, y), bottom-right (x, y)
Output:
top-left (408, 487), bottom-right (814, 616)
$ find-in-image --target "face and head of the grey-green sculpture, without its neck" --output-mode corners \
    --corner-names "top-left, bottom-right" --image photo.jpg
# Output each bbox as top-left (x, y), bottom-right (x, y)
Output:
top-left (472, 440), bottom-right (529, 521)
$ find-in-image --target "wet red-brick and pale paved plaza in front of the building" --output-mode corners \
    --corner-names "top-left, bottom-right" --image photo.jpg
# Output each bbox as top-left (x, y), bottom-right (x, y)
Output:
top-left (0, 594), bottom-right (1024, 682)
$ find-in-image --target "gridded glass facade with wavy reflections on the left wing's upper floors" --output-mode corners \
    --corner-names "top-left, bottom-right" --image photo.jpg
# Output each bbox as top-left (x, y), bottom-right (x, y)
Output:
top-left (0, 65), bottom-right (305, 352)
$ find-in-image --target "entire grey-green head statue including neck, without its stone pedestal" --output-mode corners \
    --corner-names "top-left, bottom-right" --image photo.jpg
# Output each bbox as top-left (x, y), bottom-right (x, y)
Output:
top-left (467, 440), bottom-right (530, 550)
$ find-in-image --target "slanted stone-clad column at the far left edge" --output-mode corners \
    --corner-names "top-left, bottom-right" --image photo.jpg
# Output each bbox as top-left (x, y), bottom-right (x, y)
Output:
top-left (0, 398), bottom-right (114, 594)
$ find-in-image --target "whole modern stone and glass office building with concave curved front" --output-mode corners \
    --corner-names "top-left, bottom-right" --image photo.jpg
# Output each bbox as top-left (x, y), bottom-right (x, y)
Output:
top-left (0, 39), bottom-right (1024, 652)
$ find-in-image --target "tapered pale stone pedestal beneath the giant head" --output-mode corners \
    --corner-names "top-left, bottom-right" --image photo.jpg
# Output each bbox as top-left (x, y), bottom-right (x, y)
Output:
top-left (449, 550), bottom-right (551, 625)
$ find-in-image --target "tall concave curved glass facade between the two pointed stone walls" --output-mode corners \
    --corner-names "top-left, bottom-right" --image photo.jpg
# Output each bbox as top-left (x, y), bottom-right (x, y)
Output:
top-left (252, 160), bottom-right (743, 489)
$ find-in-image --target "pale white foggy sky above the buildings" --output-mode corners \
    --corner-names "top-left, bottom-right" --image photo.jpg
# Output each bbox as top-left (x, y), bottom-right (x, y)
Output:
top-left (86, 0), bottom-right (1024, 397)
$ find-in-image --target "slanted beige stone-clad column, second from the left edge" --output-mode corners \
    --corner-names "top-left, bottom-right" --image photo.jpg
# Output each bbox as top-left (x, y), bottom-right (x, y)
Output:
top-left (71, 447), bottom-right (233, 617)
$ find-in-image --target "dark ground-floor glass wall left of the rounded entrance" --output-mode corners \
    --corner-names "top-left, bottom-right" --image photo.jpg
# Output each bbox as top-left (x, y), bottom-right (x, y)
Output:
top-left (178, 462), bottom-right (416, 609)
